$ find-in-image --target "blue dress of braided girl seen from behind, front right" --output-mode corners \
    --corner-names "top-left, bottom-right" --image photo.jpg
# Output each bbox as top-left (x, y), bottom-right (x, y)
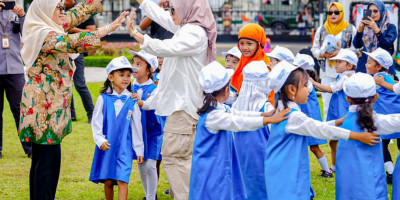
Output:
top-left (336, 112), bottom-right (388, 200)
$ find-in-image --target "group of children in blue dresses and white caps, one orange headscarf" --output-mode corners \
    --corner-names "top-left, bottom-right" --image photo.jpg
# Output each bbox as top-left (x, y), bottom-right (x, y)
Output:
top-left (86, 24), bottom-right (400, 200)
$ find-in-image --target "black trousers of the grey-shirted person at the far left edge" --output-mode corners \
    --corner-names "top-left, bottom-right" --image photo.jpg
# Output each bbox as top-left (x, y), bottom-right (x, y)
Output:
top-left (0, 74), bottom-right (32, 154)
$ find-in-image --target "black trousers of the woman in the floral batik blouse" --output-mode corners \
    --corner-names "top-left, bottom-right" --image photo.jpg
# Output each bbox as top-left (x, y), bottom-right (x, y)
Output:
top-left (29, 143), bottom-right (61, 200)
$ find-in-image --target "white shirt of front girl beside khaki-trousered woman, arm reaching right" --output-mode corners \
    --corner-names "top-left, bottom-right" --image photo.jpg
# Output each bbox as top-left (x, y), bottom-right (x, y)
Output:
top-left (205, 102), bottom-right (264, 133)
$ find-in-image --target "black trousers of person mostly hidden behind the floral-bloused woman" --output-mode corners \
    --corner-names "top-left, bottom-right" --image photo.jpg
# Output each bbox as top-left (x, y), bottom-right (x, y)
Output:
top-left (71, 54), bottom-right (94, 120)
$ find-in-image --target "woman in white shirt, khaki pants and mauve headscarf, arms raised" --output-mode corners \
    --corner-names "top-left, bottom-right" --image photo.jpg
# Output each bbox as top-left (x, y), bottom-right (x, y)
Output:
top-left (128, 0), bottom-right (217, 200)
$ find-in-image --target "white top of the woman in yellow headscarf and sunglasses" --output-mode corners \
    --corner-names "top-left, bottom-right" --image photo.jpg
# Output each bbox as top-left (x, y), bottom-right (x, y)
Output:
top-left (311, 25), bottom-right (358, 79)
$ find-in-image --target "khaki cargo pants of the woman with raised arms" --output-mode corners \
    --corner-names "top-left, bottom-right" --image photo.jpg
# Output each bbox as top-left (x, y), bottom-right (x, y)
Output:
top-left (161, 111), bottom-right (197, 200)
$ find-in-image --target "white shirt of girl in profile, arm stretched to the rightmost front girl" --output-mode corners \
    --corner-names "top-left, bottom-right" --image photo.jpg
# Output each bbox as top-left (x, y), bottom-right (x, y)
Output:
top-left (278, 101), bottom-right (350, 140)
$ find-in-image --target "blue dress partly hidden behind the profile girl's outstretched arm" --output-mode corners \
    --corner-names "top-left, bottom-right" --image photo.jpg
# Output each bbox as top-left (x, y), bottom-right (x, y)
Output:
top-left (299, 87), bottom-right (327, 146)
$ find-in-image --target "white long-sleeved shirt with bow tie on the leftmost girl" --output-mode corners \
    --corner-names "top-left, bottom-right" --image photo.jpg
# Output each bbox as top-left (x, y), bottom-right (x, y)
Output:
top-left (92, 89), bottom-right (144, 156)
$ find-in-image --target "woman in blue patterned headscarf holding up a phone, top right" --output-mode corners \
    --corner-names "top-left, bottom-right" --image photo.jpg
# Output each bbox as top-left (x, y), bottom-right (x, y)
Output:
top-left (353, 1), bottom-right (397, 74)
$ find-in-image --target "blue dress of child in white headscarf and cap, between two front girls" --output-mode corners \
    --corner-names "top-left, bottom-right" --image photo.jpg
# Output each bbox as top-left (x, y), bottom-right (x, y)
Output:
top-left (235, 101), bottom-right (269, 200)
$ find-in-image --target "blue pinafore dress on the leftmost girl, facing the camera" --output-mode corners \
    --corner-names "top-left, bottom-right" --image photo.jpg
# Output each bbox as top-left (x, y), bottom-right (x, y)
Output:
top-left (89, 93), bottom-right (136, 183)
